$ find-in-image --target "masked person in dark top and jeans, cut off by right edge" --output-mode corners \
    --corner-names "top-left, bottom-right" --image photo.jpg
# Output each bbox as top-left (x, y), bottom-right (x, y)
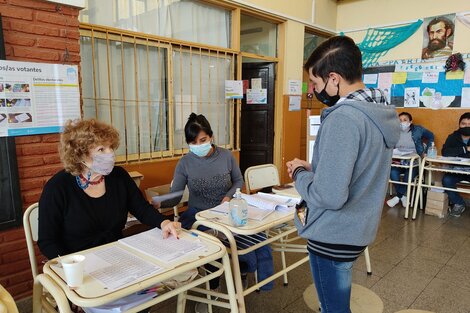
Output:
top-left (442, 112), bottom-right (470, 217)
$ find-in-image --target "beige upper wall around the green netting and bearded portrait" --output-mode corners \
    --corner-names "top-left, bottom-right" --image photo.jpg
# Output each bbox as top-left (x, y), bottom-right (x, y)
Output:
top-left (336, 0), bottom-right (470, 61)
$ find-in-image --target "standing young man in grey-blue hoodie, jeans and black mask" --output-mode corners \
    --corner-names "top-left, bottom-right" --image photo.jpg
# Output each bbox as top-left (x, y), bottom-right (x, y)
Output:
top-left (287, 36), bottom-right (400, 313)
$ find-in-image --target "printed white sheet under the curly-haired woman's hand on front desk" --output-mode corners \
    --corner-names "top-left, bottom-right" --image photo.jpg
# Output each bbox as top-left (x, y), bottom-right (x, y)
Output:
top-left (119, 228), bottom-right (206, 263)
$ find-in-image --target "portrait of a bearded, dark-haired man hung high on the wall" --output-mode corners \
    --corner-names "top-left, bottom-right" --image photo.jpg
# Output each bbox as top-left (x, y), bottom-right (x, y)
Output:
top-left (421, 14), bottom-right (455, 59)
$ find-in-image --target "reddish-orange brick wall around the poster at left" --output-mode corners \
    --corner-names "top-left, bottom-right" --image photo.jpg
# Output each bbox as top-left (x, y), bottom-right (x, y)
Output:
top-left (0, 0), bottom-right (80, 299)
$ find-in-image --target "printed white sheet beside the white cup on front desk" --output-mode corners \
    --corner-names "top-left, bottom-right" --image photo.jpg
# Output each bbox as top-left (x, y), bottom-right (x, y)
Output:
top-left (85, 246), bottom-right (162, 290)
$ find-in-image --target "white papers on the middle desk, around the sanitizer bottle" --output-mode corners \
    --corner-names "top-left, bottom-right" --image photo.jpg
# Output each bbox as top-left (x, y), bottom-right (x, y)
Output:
top-left (210, 192), bottom-right (299, 221)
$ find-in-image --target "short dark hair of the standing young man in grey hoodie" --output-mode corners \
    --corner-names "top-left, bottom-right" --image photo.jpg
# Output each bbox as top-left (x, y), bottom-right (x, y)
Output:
top-left (304, 36), bottom-right (362, 83)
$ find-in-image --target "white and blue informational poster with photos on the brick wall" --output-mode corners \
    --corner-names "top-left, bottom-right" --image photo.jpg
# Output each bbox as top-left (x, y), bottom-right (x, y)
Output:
top-left (0, 60), bottom-right (80, 137)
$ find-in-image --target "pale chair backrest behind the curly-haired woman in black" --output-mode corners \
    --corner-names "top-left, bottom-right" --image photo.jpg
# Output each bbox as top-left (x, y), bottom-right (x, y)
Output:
top-left (23, 202), bottom-right (39, 278)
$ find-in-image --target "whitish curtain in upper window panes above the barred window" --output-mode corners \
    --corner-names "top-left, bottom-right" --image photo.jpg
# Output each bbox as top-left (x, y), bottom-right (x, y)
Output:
top-left (80, 0), bottom-right (231, 48)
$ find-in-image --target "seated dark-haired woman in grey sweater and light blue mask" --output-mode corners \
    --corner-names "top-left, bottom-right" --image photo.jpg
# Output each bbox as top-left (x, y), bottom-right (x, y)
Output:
top-left (156, 113), bottom-right (274, 312)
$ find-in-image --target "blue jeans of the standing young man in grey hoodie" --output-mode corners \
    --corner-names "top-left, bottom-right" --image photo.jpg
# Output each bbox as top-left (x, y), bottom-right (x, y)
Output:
top-left (309, 252), bottom-right (354, 313)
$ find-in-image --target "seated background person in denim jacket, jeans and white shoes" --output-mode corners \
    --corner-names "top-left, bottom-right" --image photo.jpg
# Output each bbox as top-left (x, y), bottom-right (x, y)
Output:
top-left (387, 112), bottom-right (434, 208)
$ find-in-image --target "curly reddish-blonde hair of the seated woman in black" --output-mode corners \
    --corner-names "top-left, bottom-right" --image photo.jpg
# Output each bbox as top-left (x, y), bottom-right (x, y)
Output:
top-left (59, 119), bottom-right (119, 176)
